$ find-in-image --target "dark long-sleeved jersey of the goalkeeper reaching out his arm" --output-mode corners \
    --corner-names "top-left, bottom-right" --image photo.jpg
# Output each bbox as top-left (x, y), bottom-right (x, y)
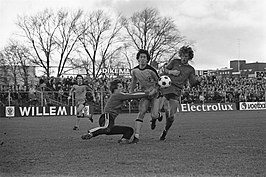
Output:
top-left (104, 92), bottom-right (147, 117)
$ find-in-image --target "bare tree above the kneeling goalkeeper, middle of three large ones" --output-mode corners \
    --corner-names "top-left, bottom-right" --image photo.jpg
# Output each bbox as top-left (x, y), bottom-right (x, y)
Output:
top-left (74, 10), bottom-right (122, 78)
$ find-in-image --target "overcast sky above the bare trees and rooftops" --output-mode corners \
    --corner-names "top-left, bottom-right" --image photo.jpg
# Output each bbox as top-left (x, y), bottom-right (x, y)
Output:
top-left (0, 0), bottom-right (266, 69)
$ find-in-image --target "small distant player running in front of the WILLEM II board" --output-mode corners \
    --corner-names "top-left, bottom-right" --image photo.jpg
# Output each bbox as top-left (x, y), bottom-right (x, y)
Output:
top-left (68, 74), bottom-right (93, 130)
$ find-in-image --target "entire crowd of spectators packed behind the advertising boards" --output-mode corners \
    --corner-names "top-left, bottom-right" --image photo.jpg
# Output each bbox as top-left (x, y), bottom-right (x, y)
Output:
top-left (0, 76), bottom-right (266, 110)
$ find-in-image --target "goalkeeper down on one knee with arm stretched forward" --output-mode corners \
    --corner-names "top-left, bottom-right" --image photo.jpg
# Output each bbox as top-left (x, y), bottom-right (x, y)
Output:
top-left (81, 80), bottom-right (153, 144)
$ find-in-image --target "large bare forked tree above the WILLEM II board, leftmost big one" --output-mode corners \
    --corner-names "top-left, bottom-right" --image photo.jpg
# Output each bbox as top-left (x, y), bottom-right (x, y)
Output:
top-left (17, 9), bottom-right (62, 77)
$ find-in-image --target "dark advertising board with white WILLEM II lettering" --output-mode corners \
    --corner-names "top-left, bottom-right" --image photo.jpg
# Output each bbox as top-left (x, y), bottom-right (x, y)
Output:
top-left (3, 106), bottom-right (93, 117)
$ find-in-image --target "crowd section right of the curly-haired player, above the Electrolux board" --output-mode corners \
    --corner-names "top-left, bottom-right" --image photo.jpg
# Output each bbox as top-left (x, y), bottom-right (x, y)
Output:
top-left (181, 76), bottom-right (266, 103)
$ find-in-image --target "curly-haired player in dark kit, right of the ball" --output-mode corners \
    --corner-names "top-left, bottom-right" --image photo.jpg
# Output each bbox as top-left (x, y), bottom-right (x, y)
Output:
top-left (160, 46), bottom-right (201, 140)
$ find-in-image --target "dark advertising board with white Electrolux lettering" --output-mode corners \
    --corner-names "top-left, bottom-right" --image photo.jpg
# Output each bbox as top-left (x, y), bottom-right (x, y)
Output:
top-left (179, 103), bottom-right (236, 112)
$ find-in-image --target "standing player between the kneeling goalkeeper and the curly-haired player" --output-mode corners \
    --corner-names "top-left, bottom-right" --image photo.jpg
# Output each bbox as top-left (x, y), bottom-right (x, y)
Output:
top-left (130, 49), bottom-right (162, 143)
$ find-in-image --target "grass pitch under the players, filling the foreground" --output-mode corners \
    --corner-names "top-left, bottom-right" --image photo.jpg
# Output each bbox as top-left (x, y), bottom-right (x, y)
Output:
top-left (0, 111), bottom-right (266, 177)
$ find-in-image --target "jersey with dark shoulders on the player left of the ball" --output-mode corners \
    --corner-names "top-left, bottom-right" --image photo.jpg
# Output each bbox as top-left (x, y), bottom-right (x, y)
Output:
top-left (131, 65), bottom-right (159, 91)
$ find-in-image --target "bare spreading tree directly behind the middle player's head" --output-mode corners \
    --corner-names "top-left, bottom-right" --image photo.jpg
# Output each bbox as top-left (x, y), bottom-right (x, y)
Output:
top-left (122, 8), bottom-right (185, 67)
